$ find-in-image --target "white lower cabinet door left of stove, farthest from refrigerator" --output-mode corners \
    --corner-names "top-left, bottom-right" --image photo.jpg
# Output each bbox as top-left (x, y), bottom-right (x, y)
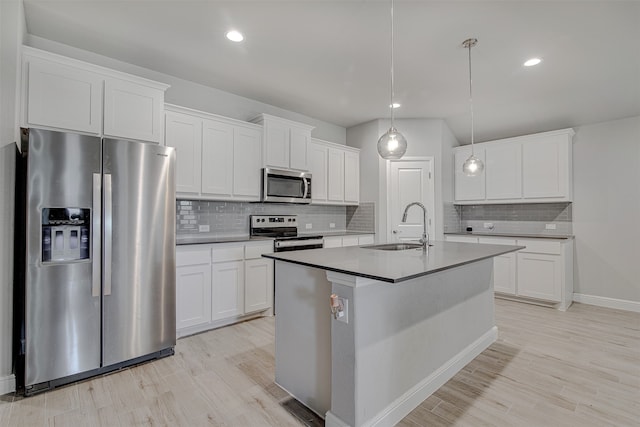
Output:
top-left (244, 258), bottom-right (273, 313)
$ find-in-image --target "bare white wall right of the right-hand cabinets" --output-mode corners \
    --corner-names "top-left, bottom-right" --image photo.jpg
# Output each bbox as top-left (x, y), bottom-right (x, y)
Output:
top-left (573, 116), bottom-right (640, 303)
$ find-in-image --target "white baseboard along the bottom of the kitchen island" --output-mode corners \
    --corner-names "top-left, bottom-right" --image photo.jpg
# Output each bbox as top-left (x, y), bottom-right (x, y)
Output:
top-left (325, 326), bottom-right (498, 427)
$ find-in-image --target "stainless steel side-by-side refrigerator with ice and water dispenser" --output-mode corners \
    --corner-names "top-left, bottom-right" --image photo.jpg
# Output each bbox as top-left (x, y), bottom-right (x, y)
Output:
top-left (14, 129), bottom-right (176, 395)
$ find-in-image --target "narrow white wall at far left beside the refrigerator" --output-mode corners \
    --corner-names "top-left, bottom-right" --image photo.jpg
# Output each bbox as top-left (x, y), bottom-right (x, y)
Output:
top-left (0, 0), bottom-right (26, 394)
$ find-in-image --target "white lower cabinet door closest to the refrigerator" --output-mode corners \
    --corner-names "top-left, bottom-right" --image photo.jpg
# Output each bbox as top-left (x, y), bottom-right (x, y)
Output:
top-left (176, 263), bottom-right (211, 330)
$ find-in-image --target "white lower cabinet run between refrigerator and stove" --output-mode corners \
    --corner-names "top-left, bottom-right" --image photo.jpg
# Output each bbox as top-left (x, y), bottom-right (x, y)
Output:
top-left (176, 241), bottom-right (273, 337)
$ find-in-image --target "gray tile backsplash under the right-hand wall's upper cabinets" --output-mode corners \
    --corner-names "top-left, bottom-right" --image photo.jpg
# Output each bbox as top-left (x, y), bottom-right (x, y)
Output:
top-left (445, 202), bottom-right (573, 235)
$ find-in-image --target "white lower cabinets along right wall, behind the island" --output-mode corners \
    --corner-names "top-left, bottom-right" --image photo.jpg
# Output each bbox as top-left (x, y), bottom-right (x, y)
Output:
top-left (445, 235), bottom-right (573, 310)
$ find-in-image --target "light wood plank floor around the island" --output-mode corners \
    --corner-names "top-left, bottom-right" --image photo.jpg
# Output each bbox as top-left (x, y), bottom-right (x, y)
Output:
top-left (0, 300), bottom-right (640, 427)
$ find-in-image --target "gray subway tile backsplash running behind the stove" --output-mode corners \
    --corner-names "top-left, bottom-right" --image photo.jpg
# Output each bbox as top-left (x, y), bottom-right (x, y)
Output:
top-left (176, 200), bottom-right (375, 237)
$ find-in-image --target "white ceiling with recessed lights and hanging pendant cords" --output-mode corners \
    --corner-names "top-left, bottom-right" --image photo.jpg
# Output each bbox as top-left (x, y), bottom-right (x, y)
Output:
top-left (24, 0), bottom-right (640, 143)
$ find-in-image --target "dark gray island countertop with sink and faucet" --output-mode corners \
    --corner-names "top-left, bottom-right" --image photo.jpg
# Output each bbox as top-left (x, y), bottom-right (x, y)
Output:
top-left (263, 241), bottom-right (524, 283)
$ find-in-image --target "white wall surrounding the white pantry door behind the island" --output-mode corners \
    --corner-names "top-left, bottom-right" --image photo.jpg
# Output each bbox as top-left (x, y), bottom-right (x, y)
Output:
top-left (347, 119), bottom-right (458, 241)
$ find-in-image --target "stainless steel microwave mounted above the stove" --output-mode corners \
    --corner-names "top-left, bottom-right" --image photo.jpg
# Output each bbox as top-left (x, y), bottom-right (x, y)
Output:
top-left (262, 168), bottom-right (311, 203)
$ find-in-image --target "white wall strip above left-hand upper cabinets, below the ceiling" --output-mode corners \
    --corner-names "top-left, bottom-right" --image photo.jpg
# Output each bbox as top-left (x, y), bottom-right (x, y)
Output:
top-left (25, 35), bottom-right (346, 144)
